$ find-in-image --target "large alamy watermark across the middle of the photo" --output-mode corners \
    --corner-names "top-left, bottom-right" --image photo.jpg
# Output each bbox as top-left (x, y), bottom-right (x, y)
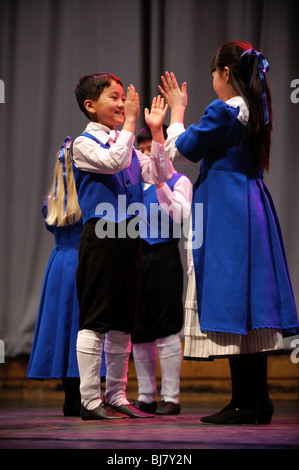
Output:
top-left (95, 195), bottom-right (203, 249)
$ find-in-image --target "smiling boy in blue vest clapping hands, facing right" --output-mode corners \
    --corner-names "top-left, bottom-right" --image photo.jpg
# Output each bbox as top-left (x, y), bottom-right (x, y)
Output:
top-left (72, 74), bottom-right (173, 420)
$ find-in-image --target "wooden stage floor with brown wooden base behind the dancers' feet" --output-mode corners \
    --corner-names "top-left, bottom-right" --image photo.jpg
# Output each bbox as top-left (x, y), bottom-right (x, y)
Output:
top-left (0, 355), bottom-right (299, 452)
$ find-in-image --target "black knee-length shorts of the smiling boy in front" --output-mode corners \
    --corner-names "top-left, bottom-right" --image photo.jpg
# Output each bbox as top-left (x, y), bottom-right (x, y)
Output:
top-left (77, 219), bottom-right (142, 333)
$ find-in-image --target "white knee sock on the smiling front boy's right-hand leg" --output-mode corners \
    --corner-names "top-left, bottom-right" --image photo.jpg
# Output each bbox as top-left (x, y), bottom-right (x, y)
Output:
top-left (104, 330), bottom-right (131, 406)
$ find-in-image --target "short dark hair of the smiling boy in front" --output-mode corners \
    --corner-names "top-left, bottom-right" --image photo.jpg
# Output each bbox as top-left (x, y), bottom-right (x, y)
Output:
top-left (75, 73), bottom-right (123, 119)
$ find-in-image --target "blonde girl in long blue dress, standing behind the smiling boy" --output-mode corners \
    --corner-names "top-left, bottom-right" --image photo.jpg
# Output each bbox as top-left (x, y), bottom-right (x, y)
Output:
top-left (27, 137), bottom-right (105, 416)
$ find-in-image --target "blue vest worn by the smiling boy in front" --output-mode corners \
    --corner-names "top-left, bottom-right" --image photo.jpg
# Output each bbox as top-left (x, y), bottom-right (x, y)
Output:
top-left (72, 132), bottom-right (143, 224)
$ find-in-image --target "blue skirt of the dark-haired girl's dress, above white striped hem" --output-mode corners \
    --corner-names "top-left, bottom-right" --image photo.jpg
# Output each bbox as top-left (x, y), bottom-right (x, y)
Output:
top-left (193, 168), bottom-right (298, 335)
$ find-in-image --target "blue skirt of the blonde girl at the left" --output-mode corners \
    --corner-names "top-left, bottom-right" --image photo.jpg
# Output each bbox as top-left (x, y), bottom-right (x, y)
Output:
top-left (27, 246), bottom-right (106, 379)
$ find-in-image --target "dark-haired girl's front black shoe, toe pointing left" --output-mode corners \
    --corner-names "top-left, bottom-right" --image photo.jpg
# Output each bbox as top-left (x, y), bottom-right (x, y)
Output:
top-left (200, 401), bottom-right (260, 425)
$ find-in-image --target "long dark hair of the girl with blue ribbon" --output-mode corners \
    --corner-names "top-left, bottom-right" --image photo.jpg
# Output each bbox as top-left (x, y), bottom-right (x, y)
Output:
top-left (211, 41), bottom-right (272, 170)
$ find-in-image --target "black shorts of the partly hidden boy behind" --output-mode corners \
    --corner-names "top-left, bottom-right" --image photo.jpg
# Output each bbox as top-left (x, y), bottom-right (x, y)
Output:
top-left (132, 241), bottom-right (184, 343)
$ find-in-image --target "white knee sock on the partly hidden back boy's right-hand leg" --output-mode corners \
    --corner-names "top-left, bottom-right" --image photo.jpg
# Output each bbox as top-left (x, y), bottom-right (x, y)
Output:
top-left (157, 334), bottom-right (182, 404)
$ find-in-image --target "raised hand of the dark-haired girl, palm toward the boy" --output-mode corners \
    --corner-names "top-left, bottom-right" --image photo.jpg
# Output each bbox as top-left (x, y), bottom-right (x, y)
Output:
top-left (158, 72), bottom-right (188, 124)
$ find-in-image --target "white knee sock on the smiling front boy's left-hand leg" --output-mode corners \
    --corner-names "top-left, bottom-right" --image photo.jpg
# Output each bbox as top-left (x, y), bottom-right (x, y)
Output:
top-left (77, 330), bottom-right (104, 410)
